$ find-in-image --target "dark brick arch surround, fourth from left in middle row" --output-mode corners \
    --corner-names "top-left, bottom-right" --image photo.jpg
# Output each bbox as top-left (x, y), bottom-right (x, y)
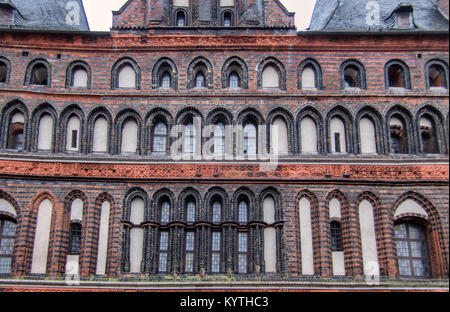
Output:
top-left (85, 106), bottom-right (113, 154)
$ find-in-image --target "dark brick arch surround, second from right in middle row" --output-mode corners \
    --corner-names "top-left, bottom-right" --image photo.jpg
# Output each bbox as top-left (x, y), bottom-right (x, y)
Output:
top-left (385, 104), bottom-right (416, 155)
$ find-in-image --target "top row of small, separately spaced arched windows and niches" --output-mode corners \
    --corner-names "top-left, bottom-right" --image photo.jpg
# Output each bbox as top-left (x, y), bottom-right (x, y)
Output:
top-left (0, 57), bottom-right (448, 90)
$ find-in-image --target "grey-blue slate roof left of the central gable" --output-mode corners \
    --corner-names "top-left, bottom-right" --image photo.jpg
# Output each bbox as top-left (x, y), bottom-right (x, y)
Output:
top-left (0, 0), bottom-right (89, 31)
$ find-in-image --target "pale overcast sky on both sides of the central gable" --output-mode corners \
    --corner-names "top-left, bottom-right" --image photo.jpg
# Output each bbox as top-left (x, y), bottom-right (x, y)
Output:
top-left (83, 0), bottom-right (316, 31)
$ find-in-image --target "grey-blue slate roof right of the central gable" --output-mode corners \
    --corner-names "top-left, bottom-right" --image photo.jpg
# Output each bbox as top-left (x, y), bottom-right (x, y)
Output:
top-left (308, 0), bottom-right (449, 32)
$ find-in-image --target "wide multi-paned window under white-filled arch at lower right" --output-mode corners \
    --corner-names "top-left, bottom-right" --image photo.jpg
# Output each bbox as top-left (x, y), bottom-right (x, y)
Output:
top-left (395, 222), bottom-right (430, 277)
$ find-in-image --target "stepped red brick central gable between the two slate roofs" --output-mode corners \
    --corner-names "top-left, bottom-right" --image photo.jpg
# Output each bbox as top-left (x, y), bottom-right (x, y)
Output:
top-left (113, 0), bottom-right (295, 31)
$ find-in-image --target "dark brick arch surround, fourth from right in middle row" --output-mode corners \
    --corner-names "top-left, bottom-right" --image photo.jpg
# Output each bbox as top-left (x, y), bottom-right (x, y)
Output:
top-left (325, 105), bottom-right (355, 155)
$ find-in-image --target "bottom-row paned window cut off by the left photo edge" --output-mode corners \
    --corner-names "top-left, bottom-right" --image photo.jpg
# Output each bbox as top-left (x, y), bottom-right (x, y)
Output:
top-left (0, 218), bottom-right (16, 275)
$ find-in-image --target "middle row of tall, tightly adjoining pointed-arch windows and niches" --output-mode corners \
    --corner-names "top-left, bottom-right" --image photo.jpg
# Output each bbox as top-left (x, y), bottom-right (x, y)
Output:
top-left (1, 102), bottom-right (448, 159)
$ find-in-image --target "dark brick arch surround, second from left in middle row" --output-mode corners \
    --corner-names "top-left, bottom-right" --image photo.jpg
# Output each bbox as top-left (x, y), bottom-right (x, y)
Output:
top-left (29, 102), bottom-right (58, 153)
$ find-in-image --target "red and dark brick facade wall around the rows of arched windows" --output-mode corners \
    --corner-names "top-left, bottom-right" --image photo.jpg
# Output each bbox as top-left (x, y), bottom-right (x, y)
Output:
top-left (0, 1), bottom-right (449, 292)
